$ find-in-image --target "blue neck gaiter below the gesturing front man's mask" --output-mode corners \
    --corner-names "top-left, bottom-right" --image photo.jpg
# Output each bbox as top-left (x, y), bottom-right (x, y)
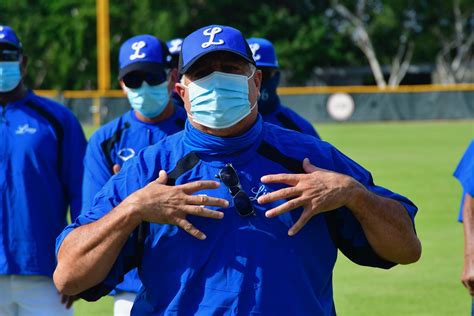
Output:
top-left (183, 115), bottom-right (263, 156)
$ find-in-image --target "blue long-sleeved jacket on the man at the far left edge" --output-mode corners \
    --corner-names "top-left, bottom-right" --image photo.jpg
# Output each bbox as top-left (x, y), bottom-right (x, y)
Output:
top-left (0, 91), bottom-right (86, 276)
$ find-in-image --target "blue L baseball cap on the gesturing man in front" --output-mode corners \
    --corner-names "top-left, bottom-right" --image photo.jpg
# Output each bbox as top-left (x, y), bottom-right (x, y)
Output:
top-left (179, 25), bottom-right (255, 74)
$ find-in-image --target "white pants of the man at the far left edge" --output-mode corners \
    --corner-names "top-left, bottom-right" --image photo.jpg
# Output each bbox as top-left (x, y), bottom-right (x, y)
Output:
top-left (0, 275), bottom-right (73, 316)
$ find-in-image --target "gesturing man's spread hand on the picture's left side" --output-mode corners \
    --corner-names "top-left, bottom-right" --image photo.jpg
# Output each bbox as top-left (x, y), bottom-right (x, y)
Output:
top-left (123, 170), bottom-right (229, 240)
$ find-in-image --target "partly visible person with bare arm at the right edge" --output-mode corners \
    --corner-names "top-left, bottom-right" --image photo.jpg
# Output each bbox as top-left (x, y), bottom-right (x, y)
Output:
top-left (454, 140), bottom-right (474, 296)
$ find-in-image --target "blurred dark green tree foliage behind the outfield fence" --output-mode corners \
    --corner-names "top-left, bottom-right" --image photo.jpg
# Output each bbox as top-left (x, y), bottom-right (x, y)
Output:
top-left (0, 0), bottom-right (474, 89)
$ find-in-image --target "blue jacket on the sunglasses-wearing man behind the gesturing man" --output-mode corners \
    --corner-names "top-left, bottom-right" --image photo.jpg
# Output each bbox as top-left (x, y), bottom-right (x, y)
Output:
top-left (82, 106), bottom-right (186, 293)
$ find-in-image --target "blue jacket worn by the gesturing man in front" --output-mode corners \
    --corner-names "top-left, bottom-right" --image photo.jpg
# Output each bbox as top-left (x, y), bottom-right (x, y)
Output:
top-left (56, 118), bottom-right (417, 315)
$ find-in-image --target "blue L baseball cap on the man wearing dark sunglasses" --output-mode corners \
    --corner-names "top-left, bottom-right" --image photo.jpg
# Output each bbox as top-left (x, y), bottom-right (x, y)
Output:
top-left (119, 34), bottom-right (169, 79)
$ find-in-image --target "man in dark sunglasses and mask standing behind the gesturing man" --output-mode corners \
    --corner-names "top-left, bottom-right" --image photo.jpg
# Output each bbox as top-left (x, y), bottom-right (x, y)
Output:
top-left (82, 35), bottom-right (186, 315)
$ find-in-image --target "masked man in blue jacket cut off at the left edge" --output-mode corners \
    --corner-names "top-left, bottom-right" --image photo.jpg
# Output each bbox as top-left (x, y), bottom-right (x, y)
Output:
top-left (0, 25), bottom-right (86, 315)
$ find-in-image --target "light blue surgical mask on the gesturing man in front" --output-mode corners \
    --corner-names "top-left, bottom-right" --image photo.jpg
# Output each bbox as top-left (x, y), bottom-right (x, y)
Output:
top-left (187, 71), bottom-right (257, 129)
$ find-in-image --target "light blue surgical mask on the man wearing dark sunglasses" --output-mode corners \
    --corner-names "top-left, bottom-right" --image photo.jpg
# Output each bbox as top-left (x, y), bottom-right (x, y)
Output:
top-left (125, 81), bottom-right (170, 118)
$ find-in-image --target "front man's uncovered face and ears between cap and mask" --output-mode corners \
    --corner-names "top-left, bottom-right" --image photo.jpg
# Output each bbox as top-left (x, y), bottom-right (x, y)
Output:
top-left (176, 52), bottom-right (262, 112)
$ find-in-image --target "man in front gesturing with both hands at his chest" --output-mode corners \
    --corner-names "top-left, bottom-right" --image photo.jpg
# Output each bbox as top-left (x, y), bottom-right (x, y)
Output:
top-left (54, 25), bottom-right (421, 315)
